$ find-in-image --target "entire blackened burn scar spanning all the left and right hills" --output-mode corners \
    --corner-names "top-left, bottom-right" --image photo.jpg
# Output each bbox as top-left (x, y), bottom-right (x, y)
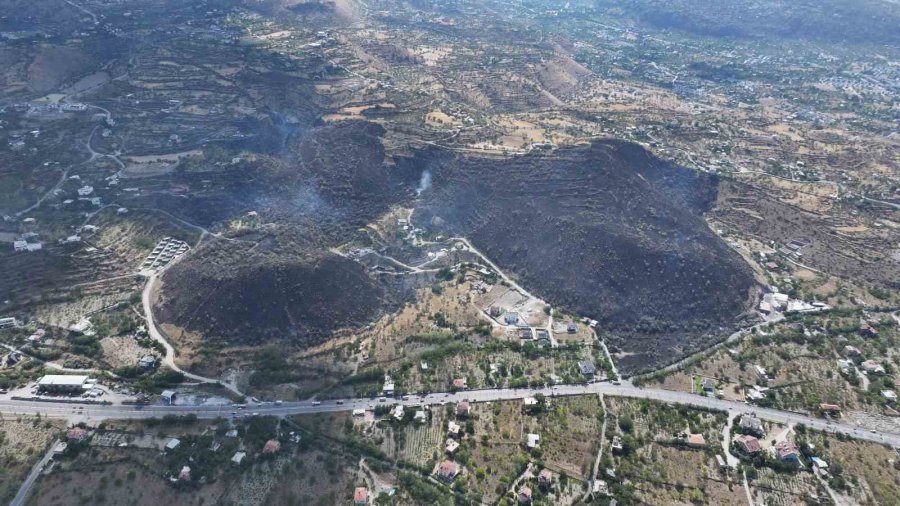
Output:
top-left (151, 122), bottom-right (753, 370)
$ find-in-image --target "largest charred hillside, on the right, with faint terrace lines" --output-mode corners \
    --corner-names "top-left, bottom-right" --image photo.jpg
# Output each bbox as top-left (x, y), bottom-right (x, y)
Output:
top-left (414, 141), bottom-right (753, 370)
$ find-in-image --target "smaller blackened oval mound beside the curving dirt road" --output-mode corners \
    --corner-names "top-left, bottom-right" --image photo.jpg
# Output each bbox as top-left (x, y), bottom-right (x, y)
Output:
top-left (156, 237), bottom-right (408, 345)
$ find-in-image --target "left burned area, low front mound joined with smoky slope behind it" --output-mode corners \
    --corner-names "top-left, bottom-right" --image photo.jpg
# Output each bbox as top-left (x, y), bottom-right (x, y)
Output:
top-left (157, 122), bottom-right (418, 344)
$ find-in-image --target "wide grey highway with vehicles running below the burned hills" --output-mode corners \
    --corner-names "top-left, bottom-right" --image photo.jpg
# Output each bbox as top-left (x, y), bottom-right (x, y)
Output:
top-left (0, 382), bottom-right (900, 448)
